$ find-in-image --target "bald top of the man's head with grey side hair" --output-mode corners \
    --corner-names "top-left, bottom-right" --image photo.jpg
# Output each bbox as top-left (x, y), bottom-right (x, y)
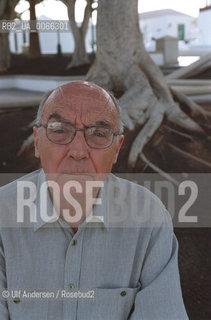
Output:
top-left (36, 81), bottom-right (123, 133)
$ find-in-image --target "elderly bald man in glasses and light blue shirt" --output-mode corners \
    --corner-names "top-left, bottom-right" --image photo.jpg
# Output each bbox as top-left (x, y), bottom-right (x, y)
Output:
top-left (0, 81), bottom-right (188, 320)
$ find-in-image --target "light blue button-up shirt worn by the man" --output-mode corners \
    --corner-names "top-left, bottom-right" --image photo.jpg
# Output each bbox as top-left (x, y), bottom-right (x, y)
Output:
top-left (0, 169), bottom-right (188, 320)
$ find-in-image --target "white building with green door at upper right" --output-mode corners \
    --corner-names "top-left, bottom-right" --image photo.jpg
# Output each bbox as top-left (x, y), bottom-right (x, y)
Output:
top-left (139, 9), bottom-right (198, 48)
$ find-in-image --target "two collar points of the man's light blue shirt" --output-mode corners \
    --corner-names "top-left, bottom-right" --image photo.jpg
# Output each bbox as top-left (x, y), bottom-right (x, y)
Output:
top-left (34, 169), bottom-right (110, 231)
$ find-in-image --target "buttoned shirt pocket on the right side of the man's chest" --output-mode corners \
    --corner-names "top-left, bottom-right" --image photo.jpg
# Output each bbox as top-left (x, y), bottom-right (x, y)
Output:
top-left (78, 288), bottom-right (140, 320)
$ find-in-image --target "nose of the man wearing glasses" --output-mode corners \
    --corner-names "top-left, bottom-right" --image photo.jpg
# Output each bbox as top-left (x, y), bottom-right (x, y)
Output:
top-left (68, 131), bottom-right (89, 160)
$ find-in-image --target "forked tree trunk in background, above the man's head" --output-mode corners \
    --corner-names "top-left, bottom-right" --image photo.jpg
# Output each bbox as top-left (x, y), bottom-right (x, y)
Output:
top-left (63, 0), bottom-right (93, 69)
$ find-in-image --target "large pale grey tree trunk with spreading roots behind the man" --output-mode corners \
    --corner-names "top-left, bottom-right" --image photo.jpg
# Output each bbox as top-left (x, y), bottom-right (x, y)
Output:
top-left (87, 0), bottom-right (209, 166)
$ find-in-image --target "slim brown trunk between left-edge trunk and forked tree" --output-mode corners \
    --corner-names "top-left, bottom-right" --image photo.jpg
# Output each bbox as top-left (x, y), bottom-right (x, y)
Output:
top-left (29, 0), bottom-right (41, 59)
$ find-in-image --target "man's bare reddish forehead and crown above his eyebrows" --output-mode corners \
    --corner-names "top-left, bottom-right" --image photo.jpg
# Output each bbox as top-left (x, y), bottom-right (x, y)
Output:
top-left (45, 82), bottom-right (114, 112)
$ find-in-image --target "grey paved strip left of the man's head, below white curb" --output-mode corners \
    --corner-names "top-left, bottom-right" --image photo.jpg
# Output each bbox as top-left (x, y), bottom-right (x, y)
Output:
top-left (0, 88), bottom-right (43, 109)
